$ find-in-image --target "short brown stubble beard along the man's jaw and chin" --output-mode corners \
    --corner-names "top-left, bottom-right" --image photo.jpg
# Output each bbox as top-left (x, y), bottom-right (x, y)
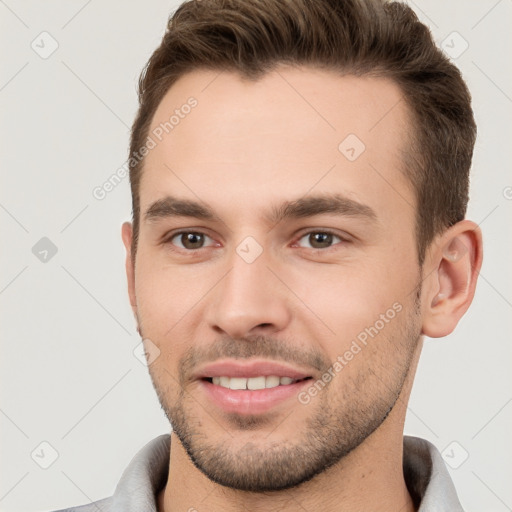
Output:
top-left (139, 303), bottom-right (420, 493)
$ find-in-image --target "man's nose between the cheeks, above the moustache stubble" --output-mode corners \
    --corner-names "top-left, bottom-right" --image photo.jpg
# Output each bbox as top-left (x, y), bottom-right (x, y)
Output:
top-left (207, 245), bottom-right (291, 338)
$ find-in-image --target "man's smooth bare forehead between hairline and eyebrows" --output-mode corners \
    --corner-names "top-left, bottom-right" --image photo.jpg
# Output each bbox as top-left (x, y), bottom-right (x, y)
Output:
top-left (140, 66), bottom-right (414, 220)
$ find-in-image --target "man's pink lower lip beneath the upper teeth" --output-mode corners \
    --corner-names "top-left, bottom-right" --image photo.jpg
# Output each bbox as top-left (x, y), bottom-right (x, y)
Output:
top-left (200, 379), bottom-right (311, 415)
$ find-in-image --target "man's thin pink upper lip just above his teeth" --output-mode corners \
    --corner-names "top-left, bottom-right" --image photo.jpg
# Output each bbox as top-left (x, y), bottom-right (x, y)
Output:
top-left (195, 359), bottom-right (311, 380)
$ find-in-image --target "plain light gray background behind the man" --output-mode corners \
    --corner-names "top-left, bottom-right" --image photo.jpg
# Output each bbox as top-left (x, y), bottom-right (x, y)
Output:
top-left (0, 0), bottom-right (512, 512)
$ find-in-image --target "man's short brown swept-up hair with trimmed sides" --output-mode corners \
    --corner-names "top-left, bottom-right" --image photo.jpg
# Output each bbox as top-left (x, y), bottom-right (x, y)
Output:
top-left (129, 0), bottom-right (476, 264)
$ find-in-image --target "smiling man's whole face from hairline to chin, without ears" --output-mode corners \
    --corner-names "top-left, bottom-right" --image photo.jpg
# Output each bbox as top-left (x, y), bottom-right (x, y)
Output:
top-left (125, 67), bottom-right (421, 491)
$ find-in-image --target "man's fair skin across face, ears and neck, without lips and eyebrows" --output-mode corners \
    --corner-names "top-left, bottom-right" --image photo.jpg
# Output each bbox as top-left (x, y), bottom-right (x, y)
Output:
top-left (122, 66), bottom-right (482, 512)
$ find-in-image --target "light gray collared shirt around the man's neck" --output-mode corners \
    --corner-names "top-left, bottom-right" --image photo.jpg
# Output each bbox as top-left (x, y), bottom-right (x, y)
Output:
top-left (51, 434), bottom-right (464, 512)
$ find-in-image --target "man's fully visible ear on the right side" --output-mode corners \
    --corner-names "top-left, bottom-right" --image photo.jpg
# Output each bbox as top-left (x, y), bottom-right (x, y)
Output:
top-left (422, 220), bottom-right (483, 338)
